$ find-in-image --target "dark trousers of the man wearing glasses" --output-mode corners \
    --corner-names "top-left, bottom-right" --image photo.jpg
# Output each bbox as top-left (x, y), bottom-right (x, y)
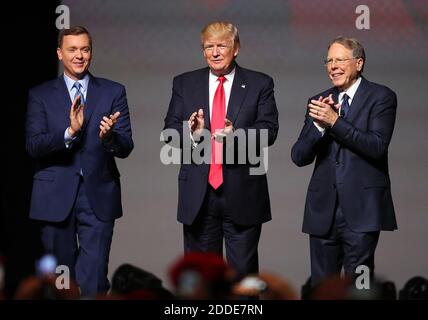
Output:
top-left (310, 203), bottom-right (379, 286)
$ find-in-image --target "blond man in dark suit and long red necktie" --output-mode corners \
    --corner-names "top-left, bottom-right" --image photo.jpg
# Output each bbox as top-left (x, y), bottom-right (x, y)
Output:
top-left (165, 22), bottom-right (278, 275)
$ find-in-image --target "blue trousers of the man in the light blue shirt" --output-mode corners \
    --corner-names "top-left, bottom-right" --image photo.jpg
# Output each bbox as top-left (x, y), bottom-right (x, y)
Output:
top-left (42, 178), bottom-right (114, 296)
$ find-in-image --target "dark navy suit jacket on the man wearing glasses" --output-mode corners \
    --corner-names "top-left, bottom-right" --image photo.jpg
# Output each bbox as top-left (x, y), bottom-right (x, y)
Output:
top-left (291, 78), bottom-right (397, 235)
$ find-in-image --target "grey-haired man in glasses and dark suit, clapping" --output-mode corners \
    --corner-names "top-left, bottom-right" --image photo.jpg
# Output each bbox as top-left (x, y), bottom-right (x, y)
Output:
top-left (291, 37), bottom-right (397, 285)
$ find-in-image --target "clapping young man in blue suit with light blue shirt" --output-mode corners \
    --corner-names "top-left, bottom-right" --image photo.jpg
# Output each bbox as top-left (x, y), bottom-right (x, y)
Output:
top-left (26, 26), bottom-right (133, 296)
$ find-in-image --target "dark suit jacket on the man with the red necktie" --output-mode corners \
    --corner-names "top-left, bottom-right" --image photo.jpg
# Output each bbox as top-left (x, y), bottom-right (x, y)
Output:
top-left (165, 65), bottom-right (278, 225)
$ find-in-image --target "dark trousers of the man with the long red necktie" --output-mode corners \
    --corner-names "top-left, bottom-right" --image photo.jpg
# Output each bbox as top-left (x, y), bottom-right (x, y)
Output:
top-left (184, 186), bottom-right (262, 276)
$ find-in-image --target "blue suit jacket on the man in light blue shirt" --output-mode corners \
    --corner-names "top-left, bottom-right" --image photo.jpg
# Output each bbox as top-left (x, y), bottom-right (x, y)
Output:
top-left (26, 75), bottom-right (134, 222)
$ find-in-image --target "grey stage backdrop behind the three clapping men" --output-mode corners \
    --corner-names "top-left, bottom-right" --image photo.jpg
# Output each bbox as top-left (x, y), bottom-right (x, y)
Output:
top-left (61, 0), bottom-right (428, 288)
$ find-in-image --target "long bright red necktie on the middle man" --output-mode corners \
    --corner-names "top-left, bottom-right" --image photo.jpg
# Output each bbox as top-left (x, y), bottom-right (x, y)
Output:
top-left (208, 76), bottom-right (226, 189)
